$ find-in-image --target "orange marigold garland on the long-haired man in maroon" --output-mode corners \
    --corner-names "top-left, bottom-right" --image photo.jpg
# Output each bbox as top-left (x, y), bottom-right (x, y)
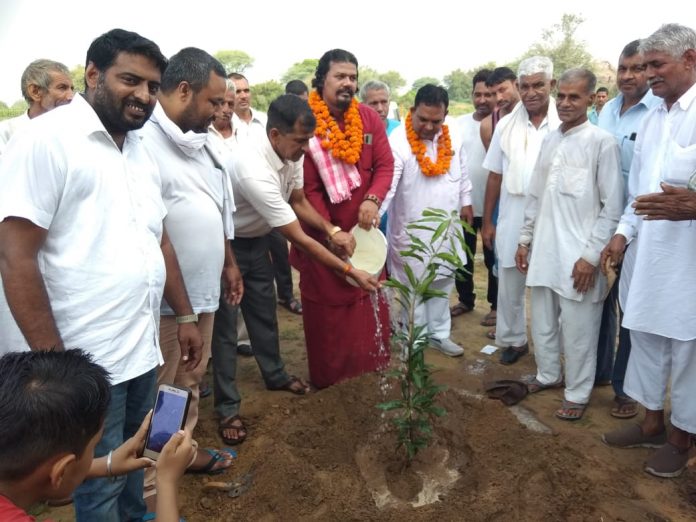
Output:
top-left (309, 91), bottom-right (363, 165)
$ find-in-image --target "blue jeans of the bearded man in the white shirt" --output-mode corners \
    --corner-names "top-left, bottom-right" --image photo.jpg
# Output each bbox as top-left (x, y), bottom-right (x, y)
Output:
top-left (73, 368), bottom-right (157, 522)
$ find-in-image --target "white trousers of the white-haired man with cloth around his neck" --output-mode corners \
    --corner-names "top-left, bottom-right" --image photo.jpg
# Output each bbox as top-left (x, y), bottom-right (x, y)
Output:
top-left (495, 267), bottom-right (527, 347)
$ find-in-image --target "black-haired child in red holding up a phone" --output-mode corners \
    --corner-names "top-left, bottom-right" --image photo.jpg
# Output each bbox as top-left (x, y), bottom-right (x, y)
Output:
top-left (0, 350), bottom-right (193, 522)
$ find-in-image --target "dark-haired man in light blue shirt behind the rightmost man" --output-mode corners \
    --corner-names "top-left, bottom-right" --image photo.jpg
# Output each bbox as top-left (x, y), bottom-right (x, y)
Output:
top-left (595, 40), bottom-right (660, 419)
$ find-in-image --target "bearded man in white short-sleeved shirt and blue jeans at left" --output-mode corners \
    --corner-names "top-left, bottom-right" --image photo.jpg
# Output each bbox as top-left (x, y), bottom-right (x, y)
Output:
top-left (0, 29), bottom-right (202, 521)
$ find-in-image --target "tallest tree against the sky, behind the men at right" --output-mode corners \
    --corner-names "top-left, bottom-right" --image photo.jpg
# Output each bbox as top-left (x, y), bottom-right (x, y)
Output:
top-left (513, 13), bottom-right (597, 78)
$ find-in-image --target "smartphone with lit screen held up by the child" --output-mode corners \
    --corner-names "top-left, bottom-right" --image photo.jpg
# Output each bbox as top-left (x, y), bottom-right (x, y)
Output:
top-left (143, 384), bottom-right (191, 460)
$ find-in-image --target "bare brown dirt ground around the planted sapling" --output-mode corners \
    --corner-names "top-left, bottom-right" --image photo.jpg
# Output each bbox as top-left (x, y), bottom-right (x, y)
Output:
top-left (38, 250), bottom-right (696, 522)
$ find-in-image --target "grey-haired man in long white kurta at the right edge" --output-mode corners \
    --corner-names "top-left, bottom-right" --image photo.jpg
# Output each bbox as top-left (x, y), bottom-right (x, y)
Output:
top-left (603, 24), bottom-right (696, 477)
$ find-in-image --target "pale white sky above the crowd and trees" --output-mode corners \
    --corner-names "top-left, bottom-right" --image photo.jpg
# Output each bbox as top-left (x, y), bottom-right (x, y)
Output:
top-left (0, 0), bottom-right (684, 104)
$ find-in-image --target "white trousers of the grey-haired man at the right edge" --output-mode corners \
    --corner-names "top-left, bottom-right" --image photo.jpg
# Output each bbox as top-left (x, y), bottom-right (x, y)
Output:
top-left (624, 330), bottom-right (696, 434)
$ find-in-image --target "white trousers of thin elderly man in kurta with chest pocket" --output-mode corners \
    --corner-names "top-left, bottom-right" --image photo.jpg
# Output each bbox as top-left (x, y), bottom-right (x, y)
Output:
top-left (531, 286), bottom-right (603, 404)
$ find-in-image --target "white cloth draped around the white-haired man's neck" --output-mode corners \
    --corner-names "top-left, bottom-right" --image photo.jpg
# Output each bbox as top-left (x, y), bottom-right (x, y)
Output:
top-left (500, 97), bottom-right (560, 196)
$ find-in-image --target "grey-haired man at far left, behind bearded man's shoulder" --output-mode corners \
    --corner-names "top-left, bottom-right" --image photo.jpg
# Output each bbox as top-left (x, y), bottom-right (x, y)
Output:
top-left (0, 60), bottom-right (74, 154)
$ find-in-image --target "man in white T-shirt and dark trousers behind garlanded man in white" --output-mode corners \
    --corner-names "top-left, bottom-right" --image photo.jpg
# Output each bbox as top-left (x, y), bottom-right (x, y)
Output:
top-left (450, 69), bottom-right (498, 320)
